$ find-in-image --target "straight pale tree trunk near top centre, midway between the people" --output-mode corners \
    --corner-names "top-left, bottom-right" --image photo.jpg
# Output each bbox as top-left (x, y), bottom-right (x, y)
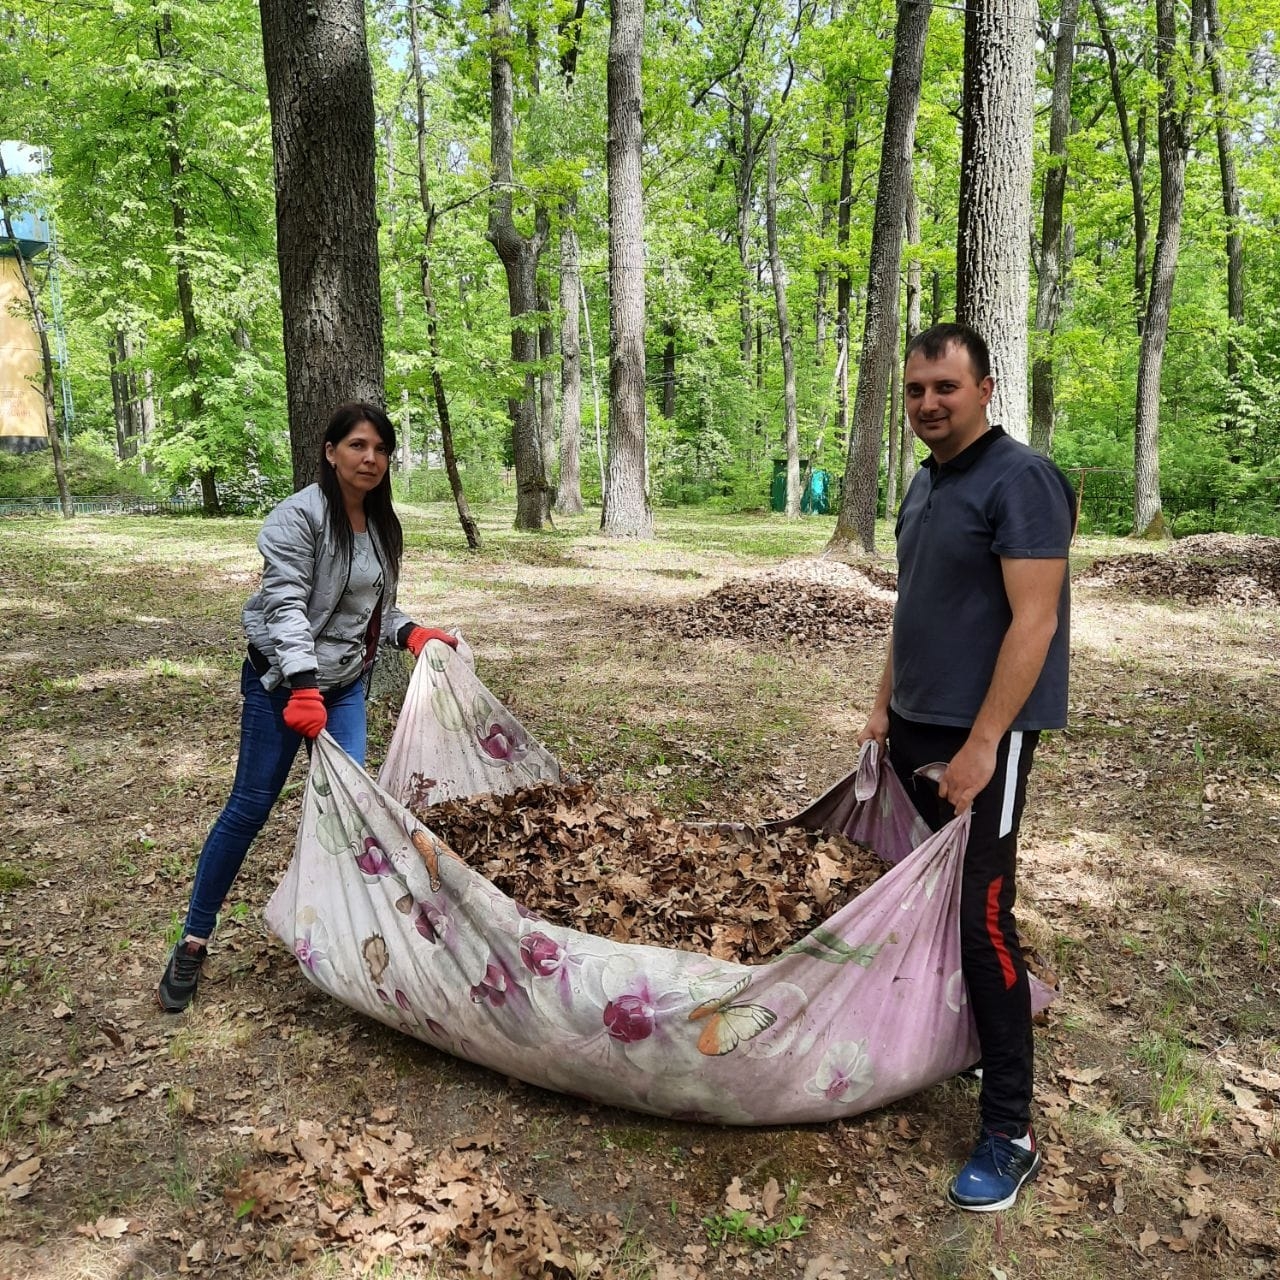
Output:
top-left (600, 0), bottom-right (653, 538)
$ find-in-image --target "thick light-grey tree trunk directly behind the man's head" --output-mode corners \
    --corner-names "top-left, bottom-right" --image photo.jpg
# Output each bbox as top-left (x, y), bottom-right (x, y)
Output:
top-left (956, 0), bottom-right (1037, 442)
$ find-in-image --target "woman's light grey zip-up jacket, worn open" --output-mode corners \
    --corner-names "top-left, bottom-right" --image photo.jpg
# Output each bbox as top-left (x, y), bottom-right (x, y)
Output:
top-left (243, 484), bottom-right (411, 689)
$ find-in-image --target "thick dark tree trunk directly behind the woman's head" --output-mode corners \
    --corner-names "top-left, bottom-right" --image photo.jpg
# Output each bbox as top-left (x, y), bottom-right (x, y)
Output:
top-left (259, 0), bottom-right (385, 489)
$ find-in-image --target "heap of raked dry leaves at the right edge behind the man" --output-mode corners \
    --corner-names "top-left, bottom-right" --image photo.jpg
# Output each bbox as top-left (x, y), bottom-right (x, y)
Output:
top-left (1076, 534), bottom-right (1280, 608)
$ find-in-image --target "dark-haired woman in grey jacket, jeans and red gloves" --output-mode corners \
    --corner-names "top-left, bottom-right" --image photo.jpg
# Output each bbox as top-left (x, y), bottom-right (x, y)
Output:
top-left (157, 404), bottom-right (457, 1014)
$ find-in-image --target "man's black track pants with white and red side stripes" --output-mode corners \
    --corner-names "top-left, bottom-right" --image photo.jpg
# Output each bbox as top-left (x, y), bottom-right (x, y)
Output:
top-left (888, 712), bottom-right (1039, 1137)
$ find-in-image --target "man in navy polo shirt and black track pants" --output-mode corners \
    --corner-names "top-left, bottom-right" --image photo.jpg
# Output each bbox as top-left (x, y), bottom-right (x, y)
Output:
top-left (859, 324), bottom-right (1075, 1211)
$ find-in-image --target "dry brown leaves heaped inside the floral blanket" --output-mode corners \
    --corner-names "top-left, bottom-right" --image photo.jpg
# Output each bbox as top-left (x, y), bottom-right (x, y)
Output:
top-left (420, 783), bottom-right (887, 964)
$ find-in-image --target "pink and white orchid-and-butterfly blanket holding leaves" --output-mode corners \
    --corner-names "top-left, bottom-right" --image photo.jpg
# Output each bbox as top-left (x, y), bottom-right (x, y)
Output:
top-left (266, 641), bottom-right (1051, 1124)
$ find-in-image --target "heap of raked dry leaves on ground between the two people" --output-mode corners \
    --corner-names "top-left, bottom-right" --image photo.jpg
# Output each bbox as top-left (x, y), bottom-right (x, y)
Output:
top-left (636, 559), bottom-right (896, 648)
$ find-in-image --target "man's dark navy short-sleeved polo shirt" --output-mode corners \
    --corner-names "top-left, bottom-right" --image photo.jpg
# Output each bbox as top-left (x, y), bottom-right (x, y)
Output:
top-left (892, 426), bottom-right (1075, 730)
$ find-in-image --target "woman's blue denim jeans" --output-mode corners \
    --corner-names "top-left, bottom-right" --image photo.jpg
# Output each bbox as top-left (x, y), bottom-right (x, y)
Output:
top-left (186, 662), bottom-right (365, 938)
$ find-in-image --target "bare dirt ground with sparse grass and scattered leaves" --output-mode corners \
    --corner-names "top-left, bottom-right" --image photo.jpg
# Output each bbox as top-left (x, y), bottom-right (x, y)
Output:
top-left (0, 507), bottom-right (1280, 1280)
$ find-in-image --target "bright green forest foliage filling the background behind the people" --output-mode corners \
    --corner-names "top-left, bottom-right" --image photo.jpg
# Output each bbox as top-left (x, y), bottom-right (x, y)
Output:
top-left (0, 0), bottom-right (1280, 534)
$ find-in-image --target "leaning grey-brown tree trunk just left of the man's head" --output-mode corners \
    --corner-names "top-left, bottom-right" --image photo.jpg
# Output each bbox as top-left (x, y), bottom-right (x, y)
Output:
top-left (831, 0), bottom-right (931, 552)
